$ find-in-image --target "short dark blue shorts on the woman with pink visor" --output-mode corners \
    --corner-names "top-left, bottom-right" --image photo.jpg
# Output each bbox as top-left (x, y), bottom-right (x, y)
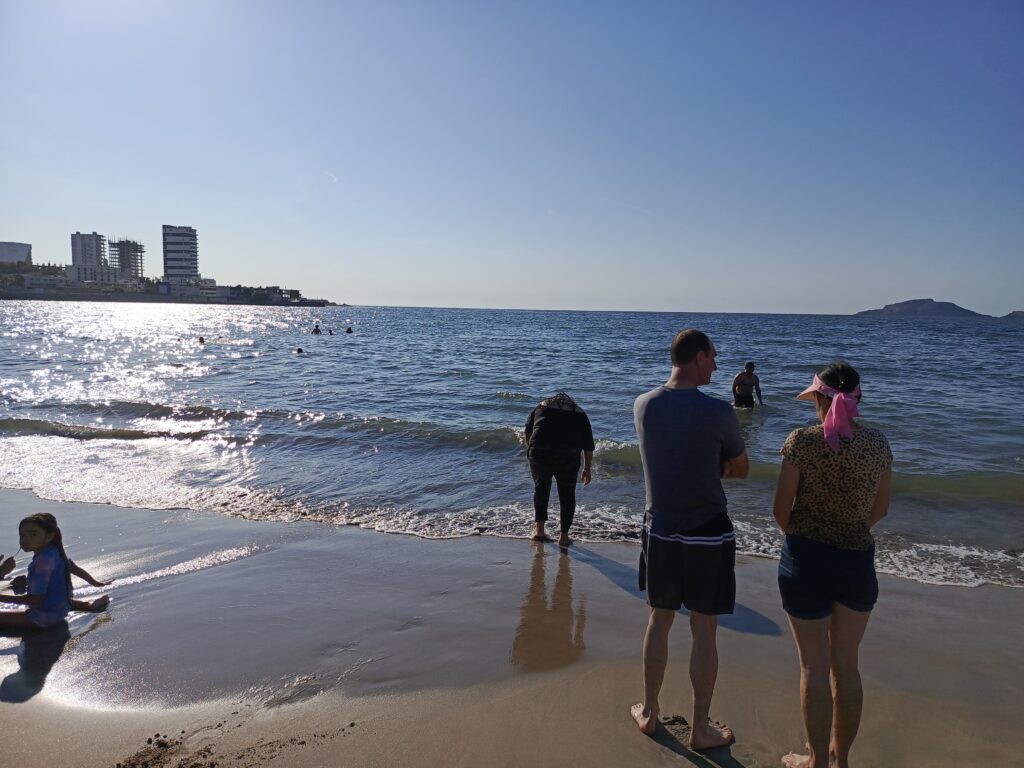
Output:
top-left (778, 536), bottom-right (879, 618)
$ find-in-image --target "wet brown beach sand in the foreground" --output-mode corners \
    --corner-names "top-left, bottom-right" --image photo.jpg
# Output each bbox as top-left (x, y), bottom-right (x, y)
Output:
top-left (0, 492), bottom-right (1024, 768)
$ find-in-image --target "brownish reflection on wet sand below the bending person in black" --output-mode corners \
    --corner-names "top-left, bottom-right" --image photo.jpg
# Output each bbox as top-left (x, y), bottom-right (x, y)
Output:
top-left (512, 544), bottom-right (587, 672)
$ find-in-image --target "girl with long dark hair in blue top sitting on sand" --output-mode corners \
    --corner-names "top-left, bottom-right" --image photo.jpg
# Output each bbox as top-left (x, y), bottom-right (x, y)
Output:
top-left (0, 512), bottom-right (111, 629)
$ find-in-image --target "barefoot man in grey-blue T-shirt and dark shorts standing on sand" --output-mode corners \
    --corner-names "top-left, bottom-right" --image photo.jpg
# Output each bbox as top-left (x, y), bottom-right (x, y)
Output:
top-left (631, 329), bottom-right (750, 752)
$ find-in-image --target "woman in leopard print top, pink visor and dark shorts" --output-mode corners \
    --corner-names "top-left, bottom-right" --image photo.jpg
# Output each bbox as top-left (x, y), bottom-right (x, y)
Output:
top-left (773, 362), bottom-right (892, 768)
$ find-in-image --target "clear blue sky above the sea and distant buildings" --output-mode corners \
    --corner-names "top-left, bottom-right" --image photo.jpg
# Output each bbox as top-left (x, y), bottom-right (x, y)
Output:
top-left (0, 0), bottom-right (1024, 315)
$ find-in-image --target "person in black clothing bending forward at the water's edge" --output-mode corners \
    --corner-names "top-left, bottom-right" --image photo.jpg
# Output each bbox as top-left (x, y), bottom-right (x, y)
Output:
top-left (525, 392), bottom-right (594, 547)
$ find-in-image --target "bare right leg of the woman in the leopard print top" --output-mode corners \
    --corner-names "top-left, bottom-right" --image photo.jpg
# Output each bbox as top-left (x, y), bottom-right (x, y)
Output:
top-left (828, 604), bottom-right (871, 768)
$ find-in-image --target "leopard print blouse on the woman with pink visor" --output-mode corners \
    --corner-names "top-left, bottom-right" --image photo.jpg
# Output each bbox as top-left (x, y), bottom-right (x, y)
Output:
top-left (780, 424), bottom-right (893, 550)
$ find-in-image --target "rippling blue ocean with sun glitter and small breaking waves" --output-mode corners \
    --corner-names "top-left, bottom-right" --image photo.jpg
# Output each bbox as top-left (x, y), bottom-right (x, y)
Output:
top-left (0, 301), bottom-right (1024, 587)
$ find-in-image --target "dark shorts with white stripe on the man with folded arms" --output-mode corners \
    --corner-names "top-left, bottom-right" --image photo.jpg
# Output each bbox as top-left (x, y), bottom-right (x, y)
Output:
top-left (639, 513), bottom-right (736, 615)
